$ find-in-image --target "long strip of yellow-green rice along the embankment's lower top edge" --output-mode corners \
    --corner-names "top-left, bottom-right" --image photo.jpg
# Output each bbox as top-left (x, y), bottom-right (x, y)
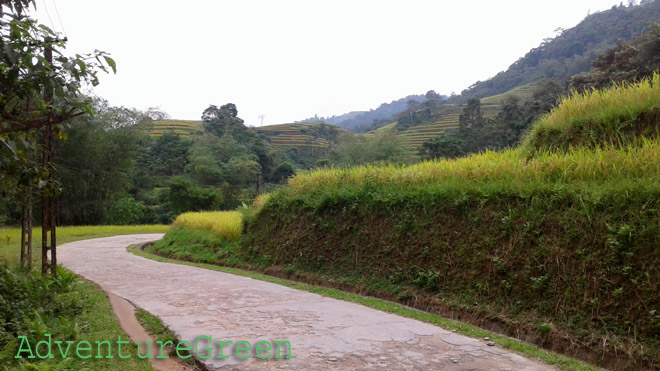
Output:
top-left (289, 139), bottom-right (660, 192)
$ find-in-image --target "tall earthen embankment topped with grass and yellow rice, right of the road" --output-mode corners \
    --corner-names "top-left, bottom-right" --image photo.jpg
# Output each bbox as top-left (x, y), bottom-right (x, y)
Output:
top-left (239, 76), bottom-right (660, 367)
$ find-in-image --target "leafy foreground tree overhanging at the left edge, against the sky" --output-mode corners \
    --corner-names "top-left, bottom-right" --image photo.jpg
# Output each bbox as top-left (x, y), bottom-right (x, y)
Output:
top-left (0, 0), bottom-right (115, 225)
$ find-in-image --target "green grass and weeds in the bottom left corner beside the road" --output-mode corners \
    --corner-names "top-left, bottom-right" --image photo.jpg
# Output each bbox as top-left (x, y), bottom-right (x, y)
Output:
top-left (0, 266), bottom-right (152, 371)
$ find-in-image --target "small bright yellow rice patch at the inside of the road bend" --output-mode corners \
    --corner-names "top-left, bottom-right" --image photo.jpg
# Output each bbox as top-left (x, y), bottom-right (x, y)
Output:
top-left (173, 211), bottom-right (243, 242)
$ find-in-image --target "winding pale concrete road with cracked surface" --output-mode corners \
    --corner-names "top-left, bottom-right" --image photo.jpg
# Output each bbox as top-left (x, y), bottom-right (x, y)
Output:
top-left (58, 234), bottom-right (554, 370)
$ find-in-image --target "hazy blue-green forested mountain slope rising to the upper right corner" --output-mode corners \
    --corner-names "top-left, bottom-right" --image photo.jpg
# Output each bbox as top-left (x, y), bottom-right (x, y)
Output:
top-left (451, 0), bottom-right (660, 103)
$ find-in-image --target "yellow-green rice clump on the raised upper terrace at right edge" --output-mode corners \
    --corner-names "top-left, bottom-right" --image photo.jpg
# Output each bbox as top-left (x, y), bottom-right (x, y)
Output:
top-left (523, 73), bottom-right (660, 154)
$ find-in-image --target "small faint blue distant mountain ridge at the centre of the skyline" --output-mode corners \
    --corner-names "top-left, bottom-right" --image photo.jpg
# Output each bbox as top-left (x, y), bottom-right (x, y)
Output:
top-left (296, 95), bottom-right (426, 131)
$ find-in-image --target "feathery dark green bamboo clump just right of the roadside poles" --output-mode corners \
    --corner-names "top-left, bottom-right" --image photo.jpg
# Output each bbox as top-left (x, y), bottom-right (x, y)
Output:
top-left (55, 99), bottom-right (146, 225)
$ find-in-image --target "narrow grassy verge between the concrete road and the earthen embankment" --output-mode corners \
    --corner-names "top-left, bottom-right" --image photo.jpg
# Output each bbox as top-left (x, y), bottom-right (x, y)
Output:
top-left (129, 246), bottom-right (598, 370)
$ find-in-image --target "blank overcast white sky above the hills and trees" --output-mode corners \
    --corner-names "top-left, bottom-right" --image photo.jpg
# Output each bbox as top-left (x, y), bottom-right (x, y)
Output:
top-left (31, 0), bottom-right (619, 125)
